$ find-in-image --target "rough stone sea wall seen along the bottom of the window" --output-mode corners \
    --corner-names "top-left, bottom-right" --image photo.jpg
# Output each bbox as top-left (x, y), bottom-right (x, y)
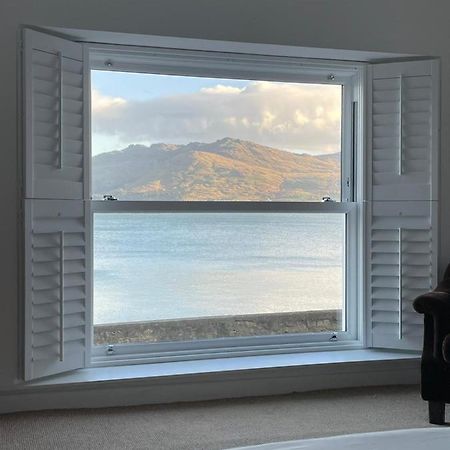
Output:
top-left (94, 310), bottom-right (341, 345)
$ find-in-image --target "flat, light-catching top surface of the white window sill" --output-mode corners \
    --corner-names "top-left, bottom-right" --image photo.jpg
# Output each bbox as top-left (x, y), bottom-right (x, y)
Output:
top-left (26, 349), bottom-right (420, 387)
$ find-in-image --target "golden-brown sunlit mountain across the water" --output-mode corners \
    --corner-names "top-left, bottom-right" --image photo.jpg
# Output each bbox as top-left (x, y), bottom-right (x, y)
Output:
top-left (93, 138), bottom-right (340, 201)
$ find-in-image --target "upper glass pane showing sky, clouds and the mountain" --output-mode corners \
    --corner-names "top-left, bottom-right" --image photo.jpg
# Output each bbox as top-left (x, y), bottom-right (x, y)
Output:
top-left (92, 71), bottom-right (342, 201)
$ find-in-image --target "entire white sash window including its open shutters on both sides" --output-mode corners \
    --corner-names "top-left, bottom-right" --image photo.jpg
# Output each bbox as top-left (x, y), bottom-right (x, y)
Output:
top-left (23, 30), bottom-right (439, 380)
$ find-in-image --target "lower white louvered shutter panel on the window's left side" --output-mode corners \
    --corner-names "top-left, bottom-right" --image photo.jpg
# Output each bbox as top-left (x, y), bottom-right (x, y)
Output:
top-left (25, 200), bottom-right (89, 380)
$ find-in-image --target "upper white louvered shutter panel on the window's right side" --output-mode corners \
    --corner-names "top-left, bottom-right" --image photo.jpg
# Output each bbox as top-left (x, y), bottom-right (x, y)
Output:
top-left (369, 60), bottom-right (439, 201)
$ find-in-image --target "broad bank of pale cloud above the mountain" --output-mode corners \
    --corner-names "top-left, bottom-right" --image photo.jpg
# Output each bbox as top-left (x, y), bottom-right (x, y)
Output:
top-left (92, 81), bottom-right (341, 153)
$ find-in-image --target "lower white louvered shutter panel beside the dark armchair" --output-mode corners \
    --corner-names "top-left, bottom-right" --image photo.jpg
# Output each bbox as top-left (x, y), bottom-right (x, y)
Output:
top-left (368, 201), bottom-right (436, 350)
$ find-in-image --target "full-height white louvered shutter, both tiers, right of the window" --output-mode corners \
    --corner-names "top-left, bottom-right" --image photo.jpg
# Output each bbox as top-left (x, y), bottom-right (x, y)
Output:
top-left (366, 60), bottom-right (439, 350)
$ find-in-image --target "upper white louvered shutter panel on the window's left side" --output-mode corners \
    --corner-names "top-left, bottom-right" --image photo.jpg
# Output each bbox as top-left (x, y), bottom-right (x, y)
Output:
top-left (23, 30), bottom-right (86, 199)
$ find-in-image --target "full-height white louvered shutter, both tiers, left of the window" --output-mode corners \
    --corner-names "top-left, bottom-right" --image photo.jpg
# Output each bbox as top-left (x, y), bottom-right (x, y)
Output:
top-left (23, 30), bottom-right (90, 380)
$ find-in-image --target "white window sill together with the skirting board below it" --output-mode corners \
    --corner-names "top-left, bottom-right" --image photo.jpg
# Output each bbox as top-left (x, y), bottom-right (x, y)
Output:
top-left (0, 349), bottom-right (420, 414)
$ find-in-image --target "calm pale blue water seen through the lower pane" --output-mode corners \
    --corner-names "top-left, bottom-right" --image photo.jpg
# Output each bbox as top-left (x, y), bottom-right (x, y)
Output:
top-left (94, 213), bottom-right (345, 324)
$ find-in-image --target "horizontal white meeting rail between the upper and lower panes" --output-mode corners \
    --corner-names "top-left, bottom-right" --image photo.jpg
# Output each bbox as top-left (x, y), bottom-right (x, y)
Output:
top-left (91, 200), bottom-right (356, 213)
